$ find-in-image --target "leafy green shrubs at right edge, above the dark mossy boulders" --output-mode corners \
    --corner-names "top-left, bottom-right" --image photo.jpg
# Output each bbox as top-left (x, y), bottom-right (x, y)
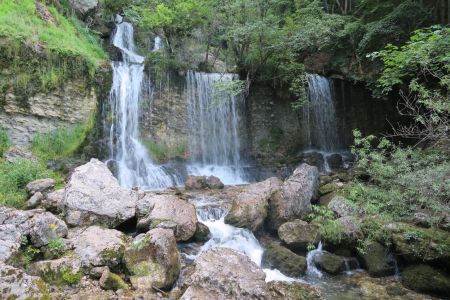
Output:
top-left (345, 131), bottom-right (450, 224)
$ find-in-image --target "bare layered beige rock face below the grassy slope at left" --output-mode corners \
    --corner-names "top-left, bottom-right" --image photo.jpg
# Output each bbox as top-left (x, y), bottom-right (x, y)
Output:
top-left (0, 80), bottom-right (97, 145)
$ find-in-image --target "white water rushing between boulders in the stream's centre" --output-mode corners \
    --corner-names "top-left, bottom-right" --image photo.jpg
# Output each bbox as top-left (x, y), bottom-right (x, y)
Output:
top-left (190, 198), bottom-right (298, 282)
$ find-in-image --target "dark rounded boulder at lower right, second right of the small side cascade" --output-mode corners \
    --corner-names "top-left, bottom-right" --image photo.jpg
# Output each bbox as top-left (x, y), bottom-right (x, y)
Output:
top-left (360, 241), bottom-right (395, 277)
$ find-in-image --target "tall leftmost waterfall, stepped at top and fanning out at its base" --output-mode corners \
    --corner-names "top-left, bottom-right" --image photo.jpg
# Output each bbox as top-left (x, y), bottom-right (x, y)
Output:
top-left (109, 16), bottom-right (180, 189)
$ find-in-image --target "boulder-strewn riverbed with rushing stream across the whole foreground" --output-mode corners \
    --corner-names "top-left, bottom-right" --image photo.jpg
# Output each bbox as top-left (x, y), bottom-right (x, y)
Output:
top-left (0, 159), bottom-right (450, 299)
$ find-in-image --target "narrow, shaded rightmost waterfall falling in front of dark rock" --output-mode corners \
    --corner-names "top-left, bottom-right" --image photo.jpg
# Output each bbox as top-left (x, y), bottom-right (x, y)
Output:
top-left (302, 74), bottom-right (342, 152)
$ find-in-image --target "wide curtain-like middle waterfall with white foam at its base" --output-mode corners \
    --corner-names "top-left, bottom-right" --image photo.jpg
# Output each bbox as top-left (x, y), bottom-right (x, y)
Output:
top-left (186, 71), bottom-right (246, 184)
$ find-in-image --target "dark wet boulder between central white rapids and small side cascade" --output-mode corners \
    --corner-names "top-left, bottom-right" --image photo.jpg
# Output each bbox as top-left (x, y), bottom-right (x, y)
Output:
top-left (263, 242), bottom-right (307, 277)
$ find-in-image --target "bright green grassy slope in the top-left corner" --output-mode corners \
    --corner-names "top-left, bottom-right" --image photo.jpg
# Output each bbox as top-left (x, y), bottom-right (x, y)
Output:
top-left (0, 0), bottom-right (107, 100)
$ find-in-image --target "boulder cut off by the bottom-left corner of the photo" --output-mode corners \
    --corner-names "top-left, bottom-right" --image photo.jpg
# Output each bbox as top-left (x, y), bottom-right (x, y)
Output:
top-left (0, 262), bottom-right (50, 300)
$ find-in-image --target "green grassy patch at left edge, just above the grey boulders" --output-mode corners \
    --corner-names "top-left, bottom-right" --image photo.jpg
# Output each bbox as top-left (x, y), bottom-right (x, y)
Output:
top-left (0, 160), bottom-right (61, 208)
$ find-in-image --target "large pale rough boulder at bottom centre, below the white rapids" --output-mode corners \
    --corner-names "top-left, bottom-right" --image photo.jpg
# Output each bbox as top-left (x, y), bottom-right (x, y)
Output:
top-left (181, 247), bottom-right (270, 299)
